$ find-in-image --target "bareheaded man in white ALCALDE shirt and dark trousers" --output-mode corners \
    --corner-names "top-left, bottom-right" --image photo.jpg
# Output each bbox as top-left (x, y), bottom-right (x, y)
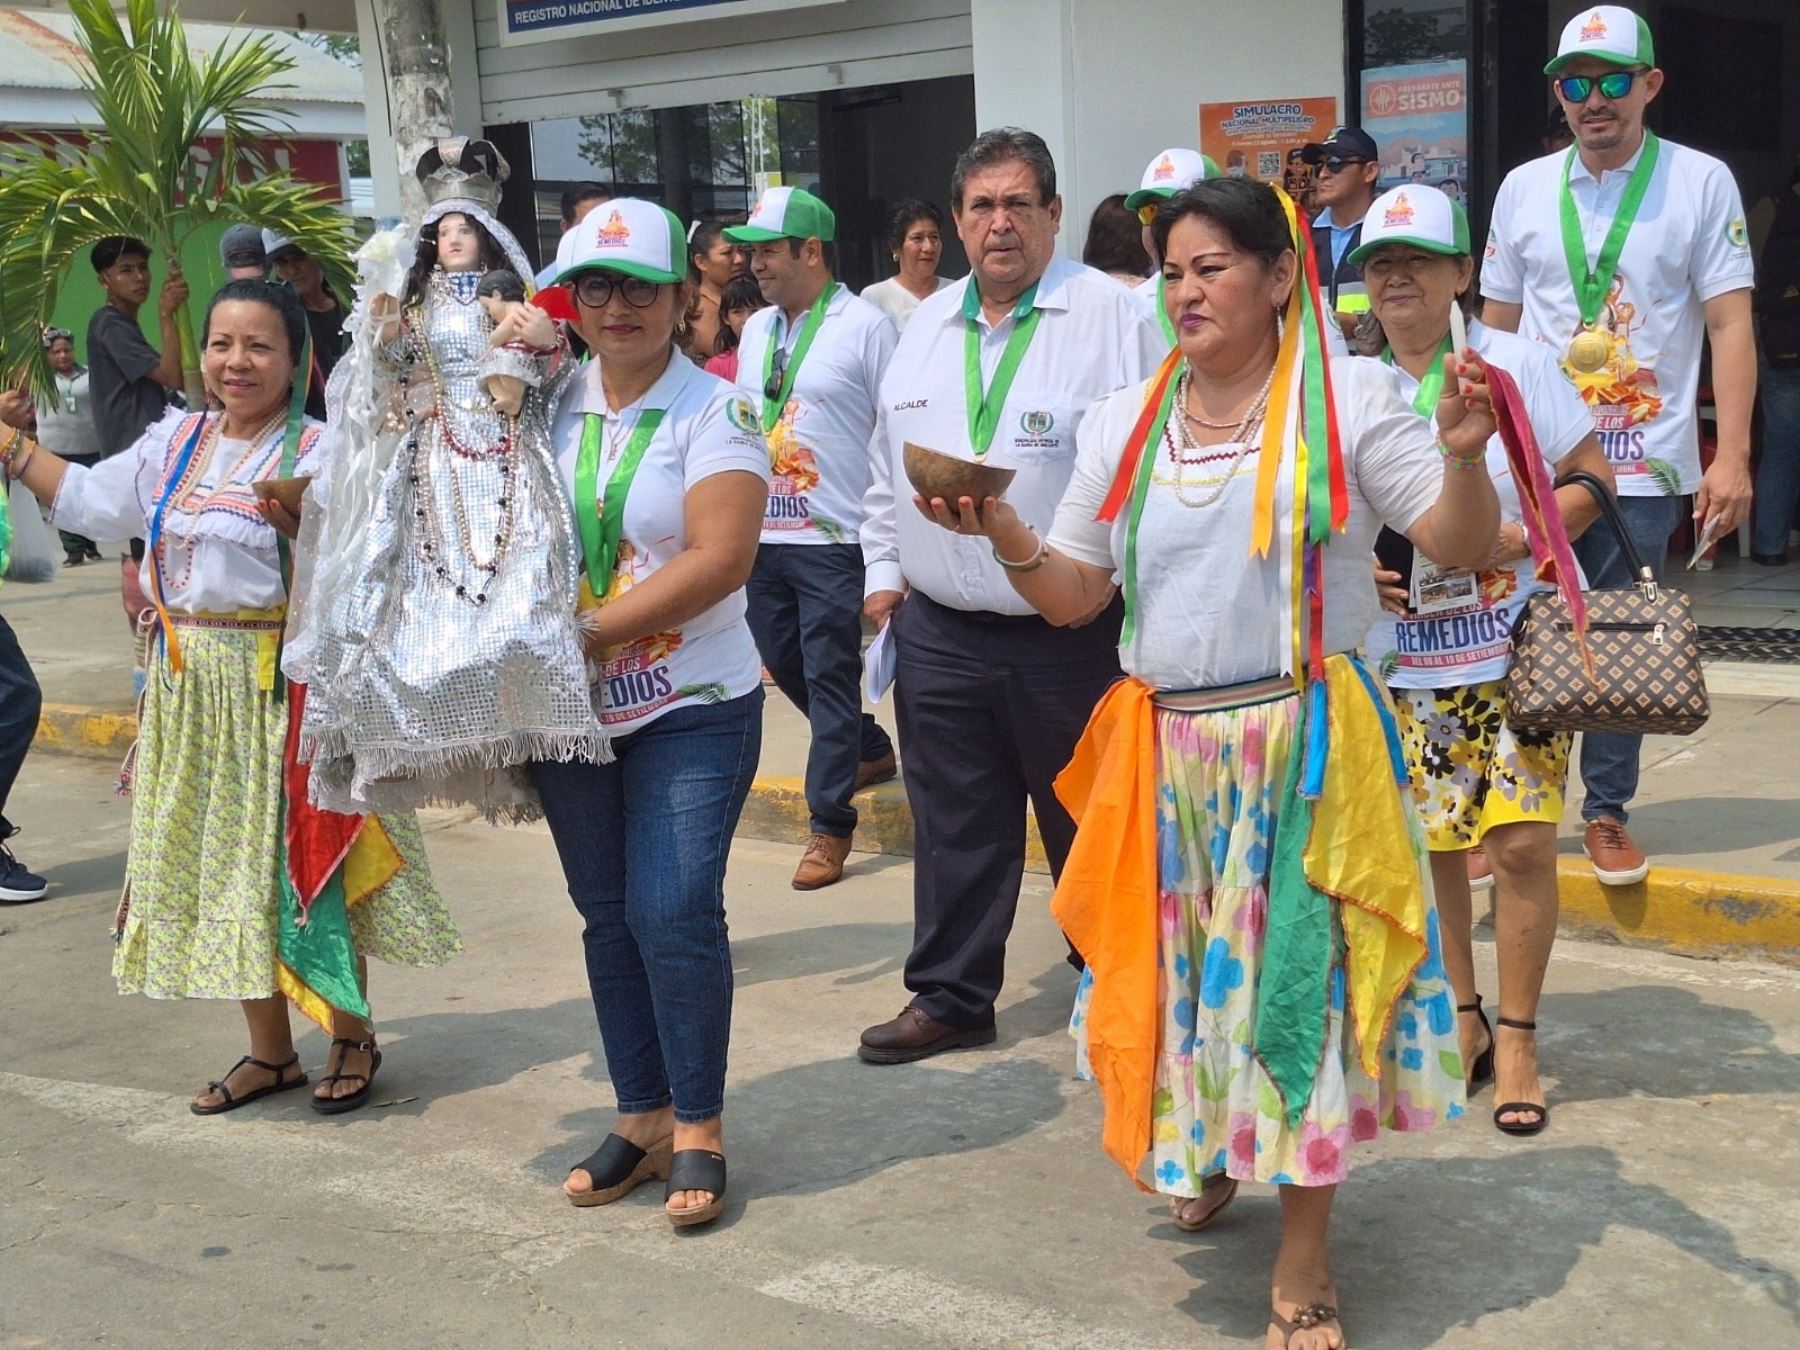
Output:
top-left (859, 128), bottom-right (1166, 1064)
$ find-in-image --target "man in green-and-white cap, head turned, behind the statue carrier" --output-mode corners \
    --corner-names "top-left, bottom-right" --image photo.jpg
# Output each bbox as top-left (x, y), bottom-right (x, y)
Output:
top-left (725, 187), bottom-right (898, 891)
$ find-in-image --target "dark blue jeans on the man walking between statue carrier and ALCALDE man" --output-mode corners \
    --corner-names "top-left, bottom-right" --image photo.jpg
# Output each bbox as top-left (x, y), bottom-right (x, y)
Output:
top-left (743, 544), bottom-right (893, 839)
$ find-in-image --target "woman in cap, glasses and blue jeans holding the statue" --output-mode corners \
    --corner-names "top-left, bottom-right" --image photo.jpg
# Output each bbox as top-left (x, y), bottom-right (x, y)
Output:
top-left (531, 198), bottom-right (769, 1228)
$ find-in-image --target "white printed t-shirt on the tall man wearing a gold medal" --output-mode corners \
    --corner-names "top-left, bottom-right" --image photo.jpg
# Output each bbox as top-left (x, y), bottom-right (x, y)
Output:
top-left (1481, 140), bottom-right (1751, 497)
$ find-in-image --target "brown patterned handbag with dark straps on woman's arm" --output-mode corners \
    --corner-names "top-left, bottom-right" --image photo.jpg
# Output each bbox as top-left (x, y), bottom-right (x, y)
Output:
top-left (1507, 473), bottom-right (1712, 736)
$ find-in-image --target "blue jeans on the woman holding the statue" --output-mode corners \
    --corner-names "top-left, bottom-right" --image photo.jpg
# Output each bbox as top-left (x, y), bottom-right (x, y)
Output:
top-left (531, 689), bottom-right (763, 1125)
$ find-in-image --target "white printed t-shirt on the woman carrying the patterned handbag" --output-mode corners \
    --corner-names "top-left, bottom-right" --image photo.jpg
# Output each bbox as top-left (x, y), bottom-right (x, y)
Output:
top-left (1368, 322), bottom-right (1593, 689)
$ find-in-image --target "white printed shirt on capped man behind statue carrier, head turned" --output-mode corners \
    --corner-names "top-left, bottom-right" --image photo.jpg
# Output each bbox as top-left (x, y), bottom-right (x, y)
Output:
top-left (738, 281), bottom-right (900, 544)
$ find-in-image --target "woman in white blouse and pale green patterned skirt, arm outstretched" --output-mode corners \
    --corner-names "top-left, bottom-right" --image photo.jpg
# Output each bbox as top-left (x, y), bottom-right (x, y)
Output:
top-left (0, 281), bottom-right (457, 1116)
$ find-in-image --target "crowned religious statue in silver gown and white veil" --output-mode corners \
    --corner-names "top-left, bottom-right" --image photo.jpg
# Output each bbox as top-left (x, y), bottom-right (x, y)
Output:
top-left (286, 140), bottom-right (607, 817)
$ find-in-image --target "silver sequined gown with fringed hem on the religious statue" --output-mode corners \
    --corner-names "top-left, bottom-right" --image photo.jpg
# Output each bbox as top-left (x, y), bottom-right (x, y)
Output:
top-left (301, 272), bottom-right (607, 819)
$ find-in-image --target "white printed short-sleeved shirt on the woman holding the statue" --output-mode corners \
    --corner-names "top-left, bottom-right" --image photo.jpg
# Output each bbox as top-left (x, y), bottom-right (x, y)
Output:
top-left (551, 355), bottom-right (769, 736)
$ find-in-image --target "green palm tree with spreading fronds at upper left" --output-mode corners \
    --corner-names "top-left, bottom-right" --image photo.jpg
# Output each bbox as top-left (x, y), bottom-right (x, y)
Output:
top-left (0, 0), bottom-right (351, 407)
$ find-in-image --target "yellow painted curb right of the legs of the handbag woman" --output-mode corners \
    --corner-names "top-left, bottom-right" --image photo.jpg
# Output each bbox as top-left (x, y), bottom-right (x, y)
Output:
top-left (1557, 859), bottom-right (1800, 965)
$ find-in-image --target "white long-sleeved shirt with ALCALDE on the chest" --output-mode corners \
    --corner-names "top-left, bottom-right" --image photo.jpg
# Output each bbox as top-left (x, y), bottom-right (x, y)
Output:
top-left (862, 257), bottom-right (1168, 614)
